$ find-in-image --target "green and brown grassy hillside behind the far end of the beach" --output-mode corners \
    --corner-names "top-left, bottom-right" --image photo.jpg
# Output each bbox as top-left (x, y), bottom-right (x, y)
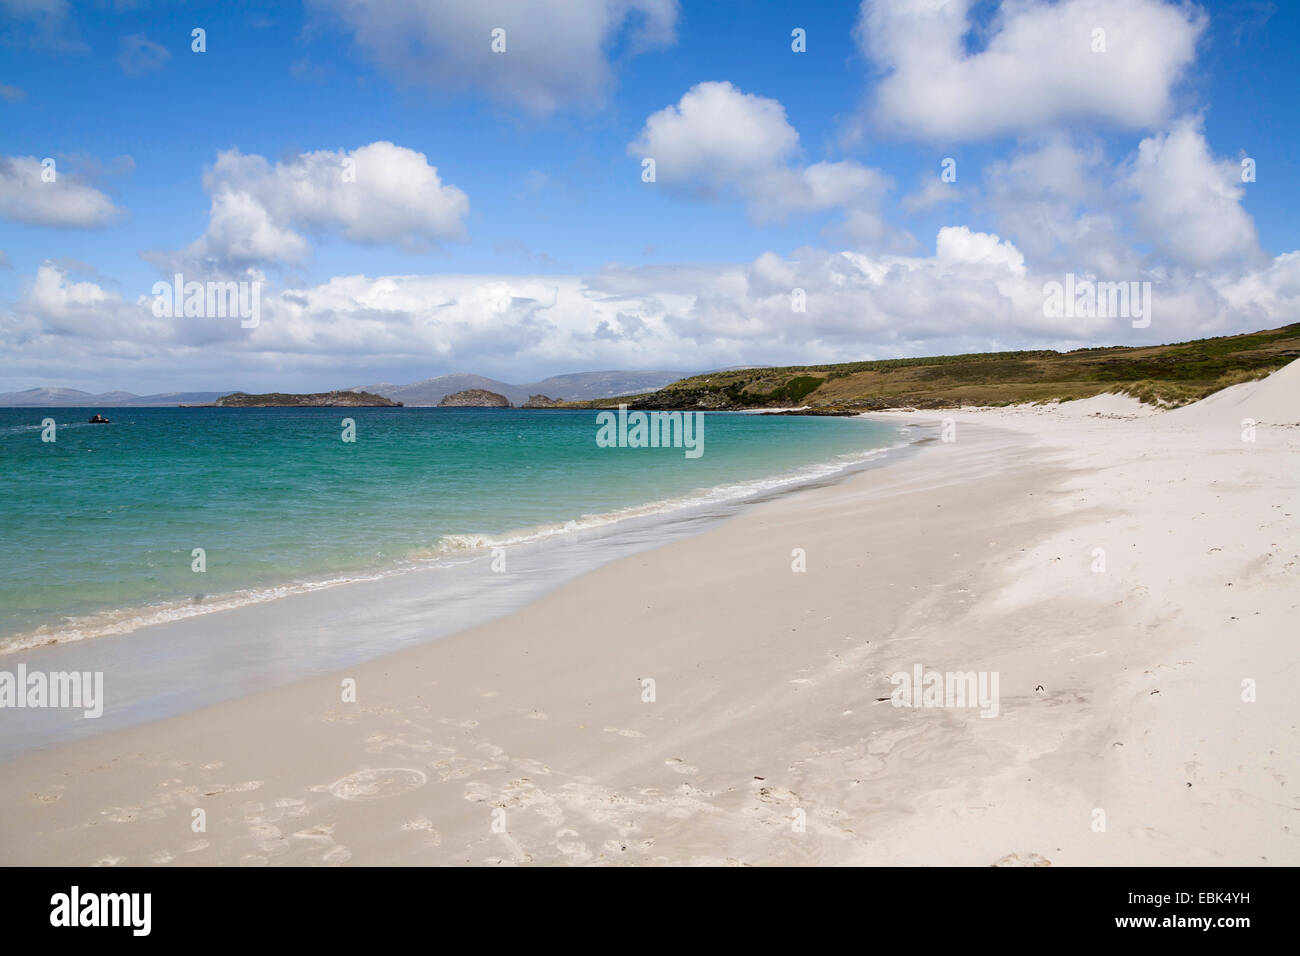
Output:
top-left (568, 323), bottom-right (1300, 415)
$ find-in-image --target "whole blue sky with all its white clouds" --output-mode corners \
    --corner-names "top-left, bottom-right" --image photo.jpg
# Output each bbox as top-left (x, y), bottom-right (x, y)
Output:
top-left (0, 0), bottom-right (1300, 392)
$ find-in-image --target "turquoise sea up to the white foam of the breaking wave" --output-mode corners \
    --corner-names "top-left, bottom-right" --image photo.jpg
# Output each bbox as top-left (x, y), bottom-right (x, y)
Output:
top-left (0, 408), bottom-right (901, 650)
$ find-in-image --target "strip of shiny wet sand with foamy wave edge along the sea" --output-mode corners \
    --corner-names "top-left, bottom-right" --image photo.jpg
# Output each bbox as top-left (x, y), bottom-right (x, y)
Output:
top-left (0, 421), bottom-right (914, 766)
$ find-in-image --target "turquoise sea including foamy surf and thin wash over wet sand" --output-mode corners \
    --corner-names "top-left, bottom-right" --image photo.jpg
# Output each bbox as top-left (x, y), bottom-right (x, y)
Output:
top-left (0, 410), bottom-right (910, 761)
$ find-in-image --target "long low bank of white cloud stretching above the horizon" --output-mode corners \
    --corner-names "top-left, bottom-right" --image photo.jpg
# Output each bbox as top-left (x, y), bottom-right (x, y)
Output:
top-left (10, 226), bottom-right (1300, 390)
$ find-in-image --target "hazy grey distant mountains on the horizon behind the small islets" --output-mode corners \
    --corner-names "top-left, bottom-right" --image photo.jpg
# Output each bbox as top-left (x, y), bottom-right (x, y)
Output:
top-left (0, 369), bottom-right (690, 407)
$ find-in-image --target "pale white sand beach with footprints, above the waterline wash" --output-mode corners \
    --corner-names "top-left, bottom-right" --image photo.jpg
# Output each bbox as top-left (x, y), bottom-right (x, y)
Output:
top-left (0, 363), bottom-right (1300, 866)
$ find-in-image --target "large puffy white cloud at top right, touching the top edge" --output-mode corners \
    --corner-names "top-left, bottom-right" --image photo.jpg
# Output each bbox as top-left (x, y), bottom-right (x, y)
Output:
top-left (854, 0), bottom-right (1206, 140)
